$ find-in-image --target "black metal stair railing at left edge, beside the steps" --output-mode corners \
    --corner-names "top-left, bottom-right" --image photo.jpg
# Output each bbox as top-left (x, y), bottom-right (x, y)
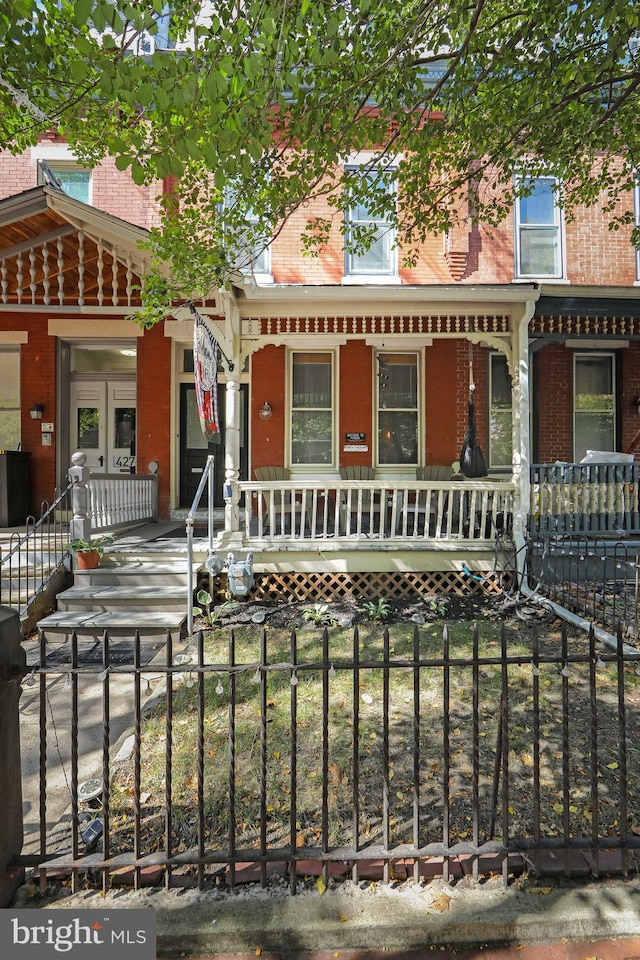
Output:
top-left (0, 483), bottom-right (72, 611)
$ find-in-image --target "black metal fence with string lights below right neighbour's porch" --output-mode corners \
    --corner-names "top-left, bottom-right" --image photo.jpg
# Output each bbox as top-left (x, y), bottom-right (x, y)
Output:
top-left (528, 536), bottom-right (640, 643)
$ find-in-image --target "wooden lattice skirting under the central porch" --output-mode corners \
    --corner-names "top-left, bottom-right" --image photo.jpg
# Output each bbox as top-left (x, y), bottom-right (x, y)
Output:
top-left (220, 571), bottom-right (508, 603)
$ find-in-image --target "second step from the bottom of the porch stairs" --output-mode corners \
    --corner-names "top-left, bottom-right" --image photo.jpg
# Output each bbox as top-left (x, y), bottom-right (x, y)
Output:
top-left (57, 578), bottom-right (187, 613)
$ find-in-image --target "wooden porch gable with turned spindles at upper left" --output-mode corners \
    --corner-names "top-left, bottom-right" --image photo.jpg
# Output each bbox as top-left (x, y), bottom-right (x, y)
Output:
top-left (0, 186), bottom-right (147, 309)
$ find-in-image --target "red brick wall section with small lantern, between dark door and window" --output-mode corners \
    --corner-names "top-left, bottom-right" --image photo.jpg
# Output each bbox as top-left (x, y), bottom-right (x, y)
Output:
top-left (249, 346), bottom-right (286, 479)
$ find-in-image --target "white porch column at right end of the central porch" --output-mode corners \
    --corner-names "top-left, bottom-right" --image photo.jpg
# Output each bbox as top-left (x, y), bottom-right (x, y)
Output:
top-left (512, 300), bottom-right (535, 577)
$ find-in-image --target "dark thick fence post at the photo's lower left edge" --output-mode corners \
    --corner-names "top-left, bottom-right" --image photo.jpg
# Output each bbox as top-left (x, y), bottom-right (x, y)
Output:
top-left (0, 606), bottom-right (27, 907)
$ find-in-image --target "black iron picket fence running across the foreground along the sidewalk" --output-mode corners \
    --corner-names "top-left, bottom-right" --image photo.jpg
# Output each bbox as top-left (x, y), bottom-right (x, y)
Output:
top-left (23, 623), bottom-right (640, 893)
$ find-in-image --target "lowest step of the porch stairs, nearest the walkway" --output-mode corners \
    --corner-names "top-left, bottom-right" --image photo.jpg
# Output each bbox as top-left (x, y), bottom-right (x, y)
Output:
top-left (38, 610), bottom-right (186, 639)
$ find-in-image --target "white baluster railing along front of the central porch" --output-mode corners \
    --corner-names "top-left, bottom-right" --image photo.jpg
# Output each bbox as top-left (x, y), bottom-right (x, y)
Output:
top-left (239, 479), bottom-right (514, 545)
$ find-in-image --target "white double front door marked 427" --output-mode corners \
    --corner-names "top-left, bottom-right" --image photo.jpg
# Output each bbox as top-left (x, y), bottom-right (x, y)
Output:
top-left (70, 380), bottom-right (136, 473)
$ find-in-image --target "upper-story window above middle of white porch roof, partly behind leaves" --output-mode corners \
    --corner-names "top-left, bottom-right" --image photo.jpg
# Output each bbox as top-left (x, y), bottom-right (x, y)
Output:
top-left (345, 168), bottom-right (398, 277)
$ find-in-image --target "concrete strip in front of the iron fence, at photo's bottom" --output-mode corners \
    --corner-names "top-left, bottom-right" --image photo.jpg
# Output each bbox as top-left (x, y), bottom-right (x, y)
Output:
top-left (13, 878), bottom-right (640, 960)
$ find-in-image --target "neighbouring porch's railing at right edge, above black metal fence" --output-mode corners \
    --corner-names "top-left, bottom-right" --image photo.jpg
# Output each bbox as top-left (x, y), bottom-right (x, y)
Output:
top-left (529, 463), bottom-right (640, 535)
